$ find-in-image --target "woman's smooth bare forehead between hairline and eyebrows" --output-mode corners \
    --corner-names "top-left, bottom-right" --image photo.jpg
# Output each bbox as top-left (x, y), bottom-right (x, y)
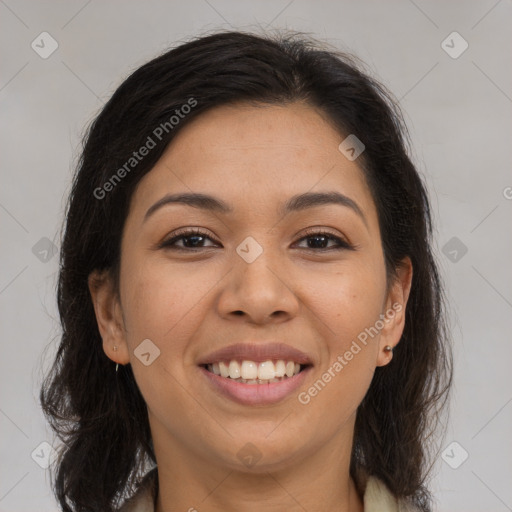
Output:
top-left (127, 103), bottom-right (375, 224)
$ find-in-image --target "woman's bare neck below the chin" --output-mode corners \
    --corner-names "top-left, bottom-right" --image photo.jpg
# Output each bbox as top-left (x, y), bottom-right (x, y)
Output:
top-left (154, 414), bottom-right (364, 512)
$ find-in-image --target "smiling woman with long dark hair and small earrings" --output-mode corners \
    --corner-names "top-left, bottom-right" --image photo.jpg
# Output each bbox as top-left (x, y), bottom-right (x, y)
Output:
top-left (41, 32), bottom-right (452, 512)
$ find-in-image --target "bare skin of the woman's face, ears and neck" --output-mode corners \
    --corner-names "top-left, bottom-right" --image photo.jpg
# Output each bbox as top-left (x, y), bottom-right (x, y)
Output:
top-left (89, 103), bottom-right (412, 512)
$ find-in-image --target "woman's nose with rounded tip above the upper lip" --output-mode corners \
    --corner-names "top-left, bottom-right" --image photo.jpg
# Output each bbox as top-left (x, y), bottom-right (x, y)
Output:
top-left (217, 244), bottom-right (300, 324)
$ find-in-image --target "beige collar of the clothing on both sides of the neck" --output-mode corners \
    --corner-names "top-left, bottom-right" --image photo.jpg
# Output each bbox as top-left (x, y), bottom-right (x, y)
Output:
top-left (120, 468), bottom-right (417, 512)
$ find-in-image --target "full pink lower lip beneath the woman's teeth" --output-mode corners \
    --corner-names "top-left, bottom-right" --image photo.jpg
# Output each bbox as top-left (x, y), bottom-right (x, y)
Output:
top-left (199, 366), bottom-right (311, 405)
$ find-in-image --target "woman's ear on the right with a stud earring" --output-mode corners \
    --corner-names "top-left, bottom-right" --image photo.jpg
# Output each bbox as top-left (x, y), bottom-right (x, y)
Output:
top-left (377, 257), bottom-right (413, 366)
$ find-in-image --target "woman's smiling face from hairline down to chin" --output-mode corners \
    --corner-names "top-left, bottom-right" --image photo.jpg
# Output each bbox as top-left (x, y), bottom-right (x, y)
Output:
top-left (91, 103), bottom-right (411, 471)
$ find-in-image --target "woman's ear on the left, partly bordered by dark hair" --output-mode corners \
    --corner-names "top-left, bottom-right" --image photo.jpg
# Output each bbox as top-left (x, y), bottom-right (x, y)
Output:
top-left (88, 270), bottom-right (130, 364)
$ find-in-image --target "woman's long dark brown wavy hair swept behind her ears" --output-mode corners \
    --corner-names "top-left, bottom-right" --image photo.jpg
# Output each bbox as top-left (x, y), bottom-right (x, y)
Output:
top-left (40, 32), bottom-right (452, 512)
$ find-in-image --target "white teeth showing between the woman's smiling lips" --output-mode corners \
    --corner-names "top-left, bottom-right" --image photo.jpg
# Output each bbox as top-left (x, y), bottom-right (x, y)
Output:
top-left (200, 359), bottom-right (310, 384)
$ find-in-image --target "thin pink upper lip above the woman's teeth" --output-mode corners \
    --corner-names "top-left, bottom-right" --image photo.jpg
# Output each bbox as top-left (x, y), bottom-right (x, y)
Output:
top-left (197, 343), bottom-right (312, 365)
